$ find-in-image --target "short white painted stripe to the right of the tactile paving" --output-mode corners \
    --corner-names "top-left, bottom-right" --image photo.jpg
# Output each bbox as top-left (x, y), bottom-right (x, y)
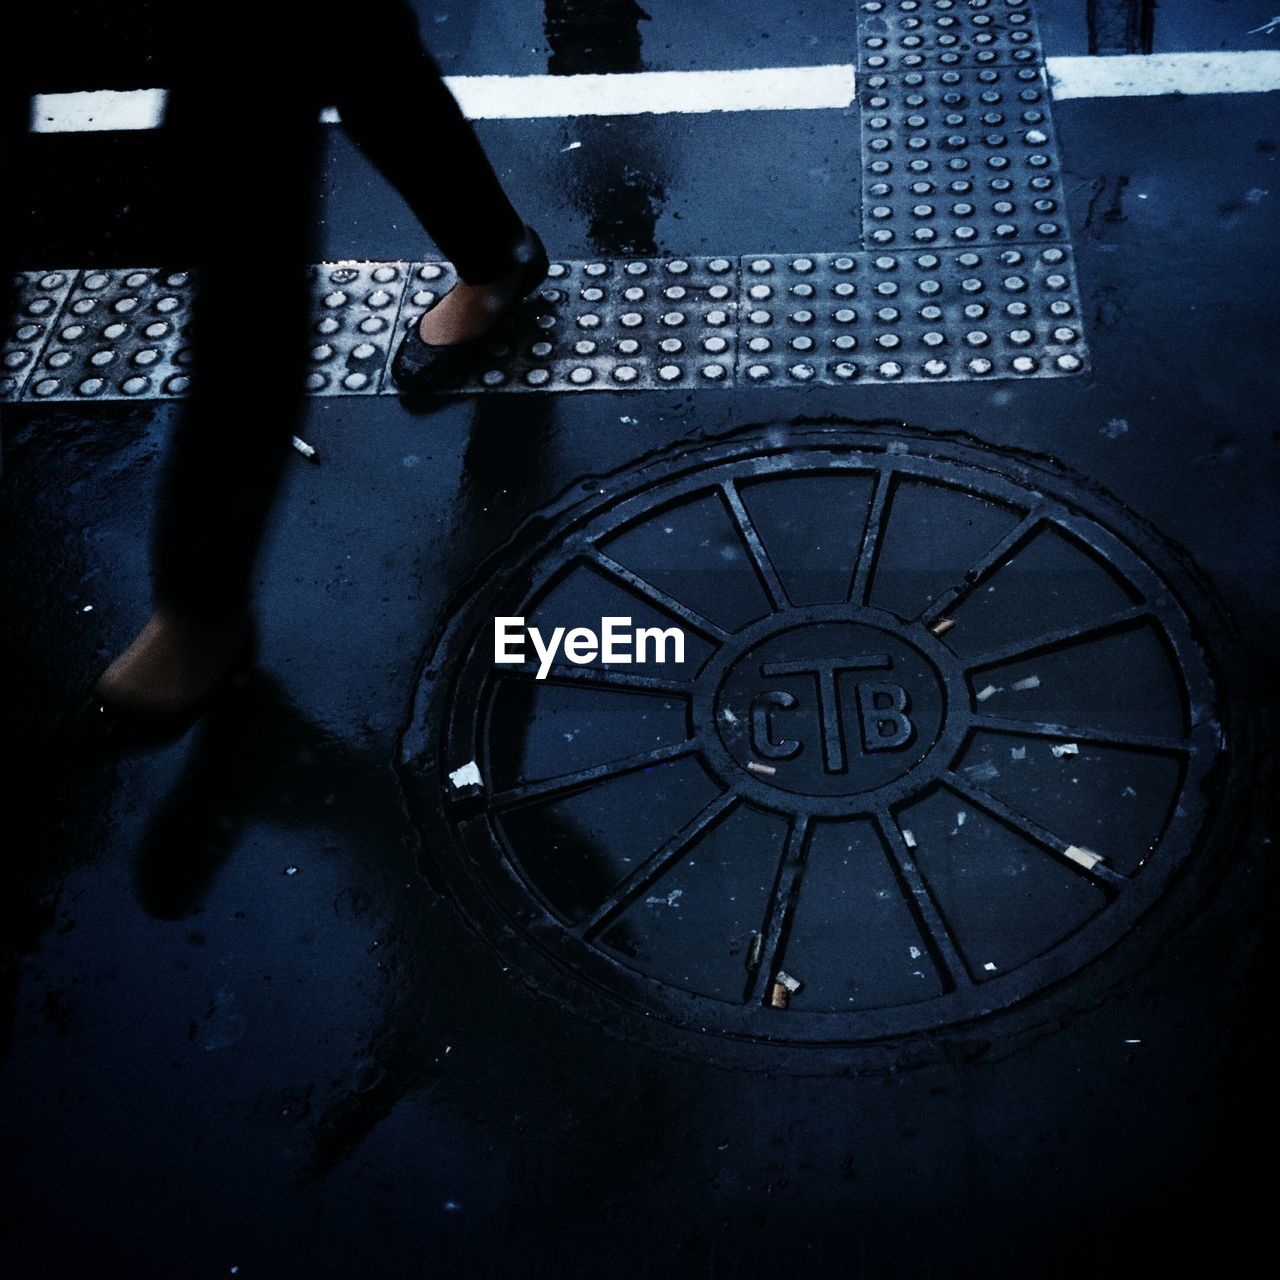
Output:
top-left (1046, 49), bottom-right (1280, 101)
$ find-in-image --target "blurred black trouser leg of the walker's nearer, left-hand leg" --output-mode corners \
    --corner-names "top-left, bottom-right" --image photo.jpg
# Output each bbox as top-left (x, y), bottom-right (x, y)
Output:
top-left (152, 78), bottom-right (320, 618)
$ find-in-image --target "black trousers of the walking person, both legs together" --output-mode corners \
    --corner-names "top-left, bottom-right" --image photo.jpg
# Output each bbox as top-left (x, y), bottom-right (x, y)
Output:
top-left (152, 0), bottom-right (524, 617)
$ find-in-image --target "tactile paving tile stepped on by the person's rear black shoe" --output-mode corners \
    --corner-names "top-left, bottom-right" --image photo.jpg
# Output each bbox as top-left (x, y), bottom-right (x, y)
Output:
top-left (388, 250), bottom-right (737, 390)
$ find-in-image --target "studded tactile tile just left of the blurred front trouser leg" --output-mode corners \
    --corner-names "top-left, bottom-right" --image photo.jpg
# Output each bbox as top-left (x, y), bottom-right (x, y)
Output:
top-left (23, 268), bottom-right (192, 401)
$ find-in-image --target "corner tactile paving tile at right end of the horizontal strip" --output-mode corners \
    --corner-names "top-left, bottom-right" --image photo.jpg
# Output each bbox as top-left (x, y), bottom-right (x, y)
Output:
top-left (739, 244), bottom-right (1088, 384)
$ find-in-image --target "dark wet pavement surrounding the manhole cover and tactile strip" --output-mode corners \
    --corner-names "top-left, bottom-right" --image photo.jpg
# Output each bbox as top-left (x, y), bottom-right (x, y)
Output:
top-left (0, 0), bottom-right (1280, 1280)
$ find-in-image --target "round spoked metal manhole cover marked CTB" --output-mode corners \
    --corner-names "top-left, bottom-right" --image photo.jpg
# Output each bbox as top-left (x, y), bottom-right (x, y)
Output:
top-left (404, 429), bottom-right (1222, 1044)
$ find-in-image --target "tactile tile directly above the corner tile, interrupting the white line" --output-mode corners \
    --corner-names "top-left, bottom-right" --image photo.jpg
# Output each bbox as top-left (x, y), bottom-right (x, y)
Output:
top-left (859, 67), bottom-right (1066, 248)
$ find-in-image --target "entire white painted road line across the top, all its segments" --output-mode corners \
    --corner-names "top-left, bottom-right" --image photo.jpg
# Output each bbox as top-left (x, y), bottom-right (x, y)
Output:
top-left (24, 49), bottom-right (1280, 133)
